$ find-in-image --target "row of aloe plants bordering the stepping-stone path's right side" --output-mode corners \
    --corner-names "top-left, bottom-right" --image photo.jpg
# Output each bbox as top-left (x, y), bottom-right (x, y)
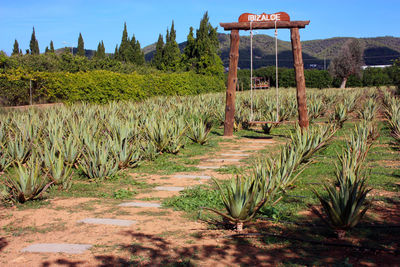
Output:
top-left (207, 125), bottom-right (337, 231)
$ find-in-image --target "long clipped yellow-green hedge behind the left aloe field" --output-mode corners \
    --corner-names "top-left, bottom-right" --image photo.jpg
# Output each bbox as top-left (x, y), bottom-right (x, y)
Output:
top-left (0, 70), bottom-right (225, 105)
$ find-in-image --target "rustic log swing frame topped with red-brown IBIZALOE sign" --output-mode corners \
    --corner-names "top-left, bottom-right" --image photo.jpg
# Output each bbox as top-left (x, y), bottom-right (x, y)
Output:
top-left (220, 12), bottom-right (310, 136)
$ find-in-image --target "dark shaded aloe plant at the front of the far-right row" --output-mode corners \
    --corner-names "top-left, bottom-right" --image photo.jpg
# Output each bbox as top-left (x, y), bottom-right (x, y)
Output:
top-left (313, 178), bottom-right (372, 238)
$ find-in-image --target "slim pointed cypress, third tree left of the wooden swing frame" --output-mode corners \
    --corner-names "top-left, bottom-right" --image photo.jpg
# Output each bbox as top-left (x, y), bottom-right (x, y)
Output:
top-left (163, 21), bottom-right (181, 71)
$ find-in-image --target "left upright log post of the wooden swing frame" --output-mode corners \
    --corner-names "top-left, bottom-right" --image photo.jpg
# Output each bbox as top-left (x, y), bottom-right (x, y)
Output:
top-left (224, 30), bottom-right (239, 136)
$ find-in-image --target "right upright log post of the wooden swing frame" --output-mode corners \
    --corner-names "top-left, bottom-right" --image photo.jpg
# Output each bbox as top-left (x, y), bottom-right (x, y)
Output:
top-left (290, 28), bottom-right (309, 129)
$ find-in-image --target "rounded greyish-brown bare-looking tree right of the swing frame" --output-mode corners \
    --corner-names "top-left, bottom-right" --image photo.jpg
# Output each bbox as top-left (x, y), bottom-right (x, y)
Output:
top-left (329, 39), bottom-right (364, 88)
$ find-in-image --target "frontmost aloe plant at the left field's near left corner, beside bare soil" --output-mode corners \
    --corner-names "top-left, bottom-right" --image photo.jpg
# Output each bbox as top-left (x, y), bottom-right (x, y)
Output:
top-left (7, 157), bottom-right (52, 203)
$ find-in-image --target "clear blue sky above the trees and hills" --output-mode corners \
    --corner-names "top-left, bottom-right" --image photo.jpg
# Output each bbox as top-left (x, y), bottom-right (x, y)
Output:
top-left (0, 0), bottom-right (400, 54)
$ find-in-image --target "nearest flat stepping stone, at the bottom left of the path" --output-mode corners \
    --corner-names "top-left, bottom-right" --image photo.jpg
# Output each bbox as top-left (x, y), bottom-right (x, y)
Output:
top-left (21, 243), bottom-right (92, 254)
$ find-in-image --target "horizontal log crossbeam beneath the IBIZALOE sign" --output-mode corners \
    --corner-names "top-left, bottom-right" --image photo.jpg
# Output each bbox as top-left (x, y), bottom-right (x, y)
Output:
top-left (219, 20), bottom-right (310, 31)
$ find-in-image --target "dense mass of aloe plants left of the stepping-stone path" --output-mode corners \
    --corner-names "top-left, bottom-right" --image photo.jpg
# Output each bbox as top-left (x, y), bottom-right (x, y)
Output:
top-left (0, 96), bottom-right (222, 202)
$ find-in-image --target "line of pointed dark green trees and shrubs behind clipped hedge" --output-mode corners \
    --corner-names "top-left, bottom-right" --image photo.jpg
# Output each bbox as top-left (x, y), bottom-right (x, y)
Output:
top-left (5, 12), bottom-right (224, 79)
